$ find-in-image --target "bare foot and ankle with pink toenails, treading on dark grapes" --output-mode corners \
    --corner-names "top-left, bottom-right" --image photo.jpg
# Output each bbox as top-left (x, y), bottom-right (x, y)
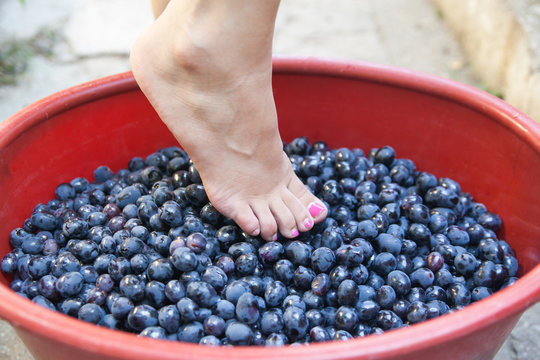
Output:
top-left (131, 0), bottom-right (327, 240)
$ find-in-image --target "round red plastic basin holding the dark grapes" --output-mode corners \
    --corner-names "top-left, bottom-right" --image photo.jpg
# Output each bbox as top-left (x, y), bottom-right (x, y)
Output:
top-left (0, 59), bottom-right (540, 360)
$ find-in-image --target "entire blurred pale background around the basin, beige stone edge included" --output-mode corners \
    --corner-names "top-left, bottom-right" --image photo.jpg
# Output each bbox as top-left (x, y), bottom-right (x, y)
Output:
top-left (0, 0), bottom-right (540, 360)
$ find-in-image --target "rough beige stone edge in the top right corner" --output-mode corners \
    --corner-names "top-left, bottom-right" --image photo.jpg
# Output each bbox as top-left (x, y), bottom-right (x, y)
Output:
top-left (430, 0), bottom-right (540, 122)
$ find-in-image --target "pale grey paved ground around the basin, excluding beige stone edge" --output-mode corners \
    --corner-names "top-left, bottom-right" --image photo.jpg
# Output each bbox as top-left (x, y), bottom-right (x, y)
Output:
top-left (0, 0), bottom-right (540, 360)
